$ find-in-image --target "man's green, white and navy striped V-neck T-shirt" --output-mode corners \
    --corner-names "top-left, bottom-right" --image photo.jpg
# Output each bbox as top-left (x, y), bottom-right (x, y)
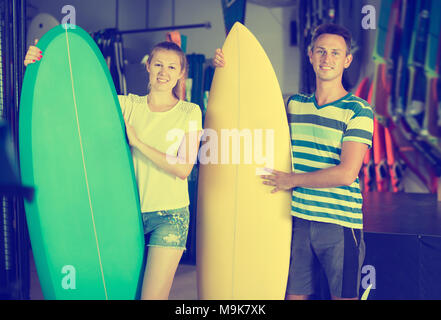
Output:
top-left (288, 93), bottom-right (373, 229)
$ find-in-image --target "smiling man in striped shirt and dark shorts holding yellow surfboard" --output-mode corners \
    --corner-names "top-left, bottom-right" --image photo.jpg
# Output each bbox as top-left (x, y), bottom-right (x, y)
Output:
top-left (262, 24), bottom-right (373, 299)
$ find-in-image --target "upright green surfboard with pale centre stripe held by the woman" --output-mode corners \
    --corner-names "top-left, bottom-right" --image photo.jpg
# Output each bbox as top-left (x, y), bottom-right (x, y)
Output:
top-left (19, 25), bottom-right (144, 299)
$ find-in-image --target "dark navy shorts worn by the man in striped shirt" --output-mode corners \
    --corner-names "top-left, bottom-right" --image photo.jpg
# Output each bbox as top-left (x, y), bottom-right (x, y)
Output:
top-left (287, 217), bottom-right (365, 298)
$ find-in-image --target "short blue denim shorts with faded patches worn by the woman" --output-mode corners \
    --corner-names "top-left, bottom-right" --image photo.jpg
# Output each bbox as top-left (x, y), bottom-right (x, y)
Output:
top-left (142, 207), bottom-right (190, 250)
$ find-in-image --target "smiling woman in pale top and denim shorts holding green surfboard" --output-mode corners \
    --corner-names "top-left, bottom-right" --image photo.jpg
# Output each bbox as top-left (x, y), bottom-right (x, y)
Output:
top-left (25, 38), bottom-right (202, 299)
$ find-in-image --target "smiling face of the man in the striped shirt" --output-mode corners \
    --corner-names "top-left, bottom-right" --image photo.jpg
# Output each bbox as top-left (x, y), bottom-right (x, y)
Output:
top-left (309, 33), bottom-right (352, 81)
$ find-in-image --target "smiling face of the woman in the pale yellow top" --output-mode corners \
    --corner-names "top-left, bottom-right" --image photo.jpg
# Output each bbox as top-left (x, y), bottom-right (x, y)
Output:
top-left (147, 50), bottom-right (183, 92)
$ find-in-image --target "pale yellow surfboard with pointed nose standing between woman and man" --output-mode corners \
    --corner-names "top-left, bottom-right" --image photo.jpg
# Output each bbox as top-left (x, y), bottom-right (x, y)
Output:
top-left (196, 23), bottom-right (292, 299)
